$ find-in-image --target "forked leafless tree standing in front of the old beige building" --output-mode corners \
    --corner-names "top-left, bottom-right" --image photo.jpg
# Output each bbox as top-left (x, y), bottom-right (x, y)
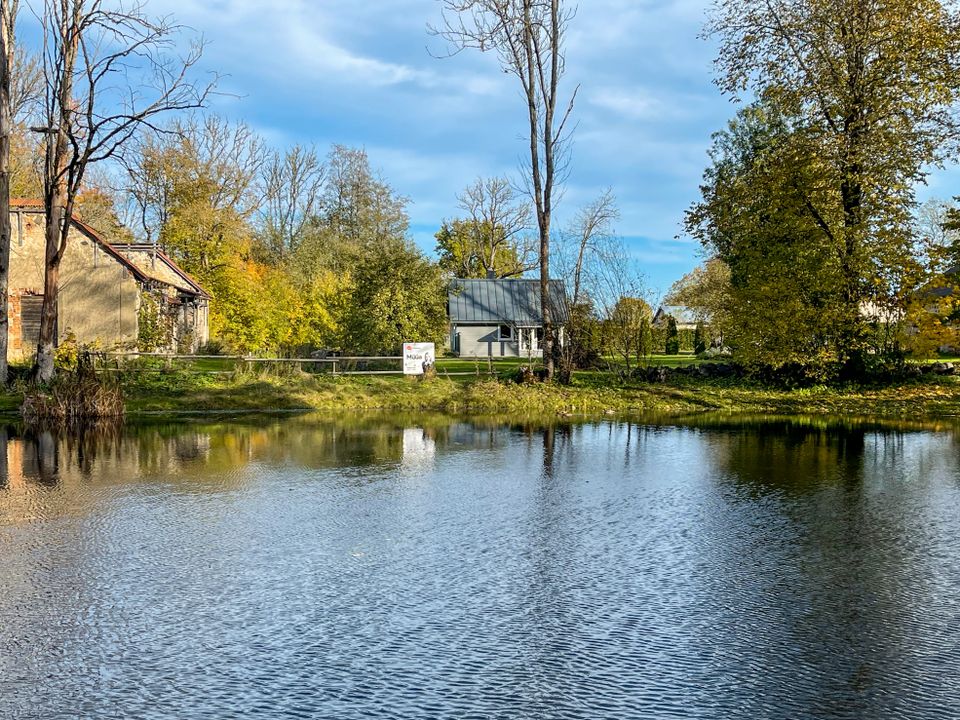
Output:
top-left (34, 0), bottom-right (213, 381)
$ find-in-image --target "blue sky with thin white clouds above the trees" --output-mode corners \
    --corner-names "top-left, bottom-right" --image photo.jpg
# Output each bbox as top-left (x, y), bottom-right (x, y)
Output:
top-left (137, 0), bottom-right (960, 291)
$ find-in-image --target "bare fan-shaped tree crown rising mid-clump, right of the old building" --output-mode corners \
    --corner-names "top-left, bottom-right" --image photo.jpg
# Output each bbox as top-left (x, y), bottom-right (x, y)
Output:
top-left (260, 145), bottom-right (326, 258)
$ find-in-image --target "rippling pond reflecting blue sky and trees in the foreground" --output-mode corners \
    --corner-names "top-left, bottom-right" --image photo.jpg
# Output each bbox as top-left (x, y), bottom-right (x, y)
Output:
top-left (0, 416), bottom-right (960, 720)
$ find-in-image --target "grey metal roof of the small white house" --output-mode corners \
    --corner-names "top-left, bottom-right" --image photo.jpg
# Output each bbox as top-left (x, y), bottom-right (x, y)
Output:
top-left (447, 278), bottom-right (567, 326)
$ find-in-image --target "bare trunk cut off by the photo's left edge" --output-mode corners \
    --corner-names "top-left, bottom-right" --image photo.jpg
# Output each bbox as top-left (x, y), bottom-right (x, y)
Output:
top-left (0, 0), bottom-right (19, 383)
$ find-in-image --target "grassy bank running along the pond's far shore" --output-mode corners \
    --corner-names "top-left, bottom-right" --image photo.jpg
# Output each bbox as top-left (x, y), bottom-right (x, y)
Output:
top-left (0, 362), bottom-right (960, 419)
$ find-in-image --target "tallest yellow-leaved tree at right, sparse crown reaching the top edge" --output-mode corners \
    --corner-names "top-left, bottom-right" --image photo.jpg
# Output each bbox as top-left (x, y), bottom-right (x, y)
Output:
top-left (706, 0), bottom-right (960, 371)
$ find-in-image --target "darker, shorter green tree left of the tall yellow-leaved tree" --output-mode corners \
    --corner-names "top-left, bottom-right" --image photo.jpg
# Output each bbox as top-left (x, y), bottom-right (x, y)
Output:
top-left (688, 103), bottom-right (844, 367)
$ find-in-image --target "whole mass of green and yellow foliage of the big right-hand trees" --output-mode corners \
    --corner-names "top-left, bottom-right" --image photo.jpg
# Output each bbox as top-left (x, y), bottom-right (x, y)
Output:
top-left (700, 0), bottom-right (960, 371)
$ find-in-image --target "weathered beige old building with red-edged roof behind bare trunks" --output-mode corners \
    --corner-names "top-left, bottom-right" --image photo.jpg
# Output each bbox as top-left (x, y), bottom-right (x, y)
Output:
top-left (8, 200), bottom-right (210, 360)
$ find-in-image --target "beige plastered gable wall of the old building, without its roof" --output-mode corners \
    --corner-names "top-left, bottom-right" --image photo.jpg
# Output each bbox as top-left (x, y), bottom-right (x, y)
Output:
top-left (8, 212), bottom-right (140, 358)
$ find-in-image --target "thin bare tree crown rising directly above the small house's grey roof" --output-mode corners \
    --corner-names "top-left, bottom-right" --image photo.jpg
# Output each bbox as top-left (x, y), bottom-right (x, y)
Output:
top-left (457, 178), bottom-right (538, 277)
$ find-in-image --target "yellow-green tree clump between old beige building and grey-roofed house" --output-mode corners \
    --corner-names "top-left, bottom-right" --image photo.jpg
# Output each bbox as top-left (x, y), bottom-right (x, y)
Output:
top-left (128, 118), bottom-right (438, 355)
